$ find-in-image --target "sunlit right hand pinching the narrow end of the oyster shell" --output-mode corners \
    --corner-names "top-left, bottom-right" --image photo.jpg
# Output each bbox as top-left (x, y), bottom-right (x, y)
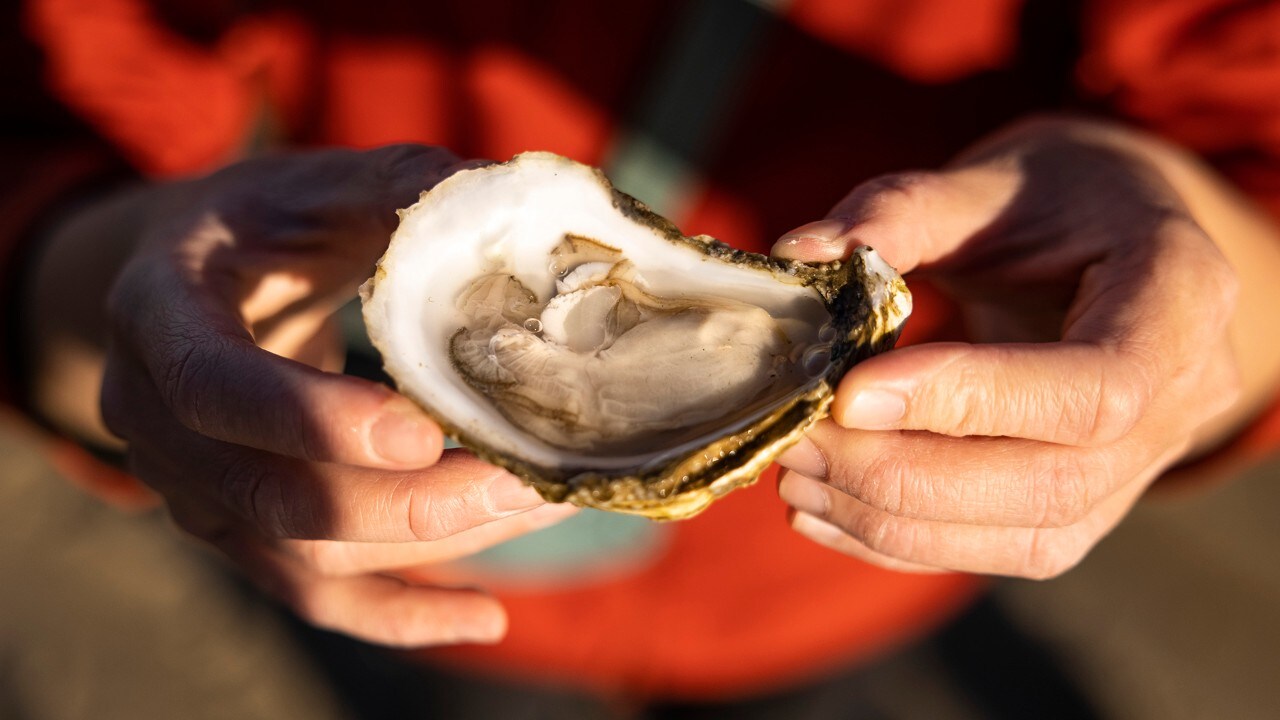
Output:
top-left (774, 122), bottom-right (1249, 578)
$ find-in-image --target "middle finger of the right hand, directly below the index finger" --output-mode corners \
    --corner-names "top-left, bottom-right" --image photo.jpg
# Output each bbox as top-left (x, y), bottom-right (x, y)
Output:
top-left (778, 421), bottom-right (1166, 528)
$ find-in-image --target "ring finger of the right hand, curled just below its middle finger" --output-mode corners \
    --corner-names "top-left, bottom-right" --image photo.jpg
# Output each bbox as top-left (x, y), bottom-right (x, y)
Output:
top-left (788, 456), bottom-right (1155, 579)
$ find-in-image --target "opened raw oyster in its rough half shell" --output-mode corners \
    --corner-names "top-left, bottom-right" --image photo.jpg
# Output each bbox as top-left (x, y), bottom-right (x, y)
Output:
top-left (361, 152), bottom-right (911, 519)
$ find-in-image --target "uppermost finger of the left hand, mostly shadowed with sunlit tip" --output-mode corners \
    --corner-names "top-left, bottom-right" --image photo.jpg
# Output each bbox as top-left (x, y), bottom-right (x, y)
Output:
top-left (104, 263), bottom-right (443, 468)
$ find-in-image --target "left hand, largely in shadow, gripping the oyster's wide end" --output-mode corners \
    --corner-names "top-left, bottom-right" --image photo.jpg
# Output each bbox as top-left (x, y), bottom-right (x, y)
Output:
top-left (90, 146), bottom-right (572, 646)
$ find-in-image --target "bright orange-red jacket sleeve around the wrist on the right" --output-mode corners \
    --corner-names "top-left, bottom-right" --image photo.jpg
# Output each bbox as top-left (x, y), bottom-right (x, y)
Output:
top-left (1079, 0), bottom-right (1280, 477)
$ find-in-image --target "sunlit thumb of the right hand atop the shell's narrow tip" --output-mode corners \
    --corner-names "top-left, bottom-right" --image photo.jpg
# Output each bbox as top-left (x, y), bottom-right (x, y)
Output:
top-left (772, 167), bottom-right (1018, 273)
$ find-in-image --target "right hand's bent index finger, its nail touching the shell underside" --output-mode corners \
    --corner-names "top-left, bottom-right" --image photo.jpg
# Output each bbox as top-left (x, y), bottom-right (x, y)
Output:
top-left (832, 220), bottom-right (1234, 446)
